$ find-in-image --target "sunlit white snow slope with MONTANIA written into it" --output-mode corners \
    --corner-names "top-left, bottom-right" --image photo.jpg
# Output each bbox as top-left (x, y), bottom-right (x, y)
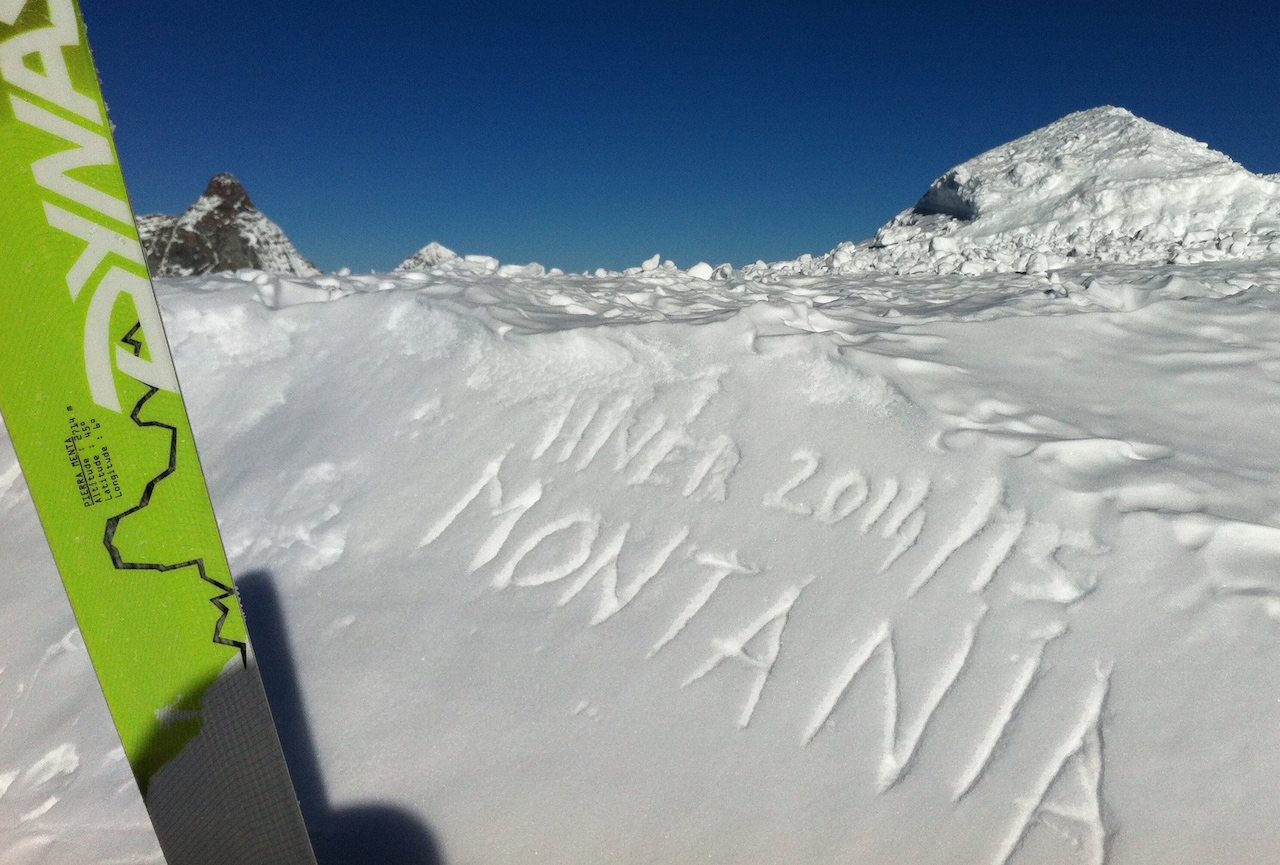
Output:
top-left (0, 260), bottom-right (1280, 865)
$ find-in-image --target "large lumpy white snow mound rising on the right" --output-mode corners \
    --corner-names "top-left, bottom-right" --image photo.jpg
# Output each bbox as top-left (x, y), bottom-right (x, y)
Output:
top-left (768, 106), bottom-right (1280, 274)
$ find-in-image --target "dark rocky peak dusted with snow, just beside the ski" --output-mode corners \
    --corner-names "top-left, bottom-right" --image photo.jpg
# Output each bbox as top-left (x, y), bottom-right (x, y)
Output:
top-left (137, 174), bottom-right (320, 276)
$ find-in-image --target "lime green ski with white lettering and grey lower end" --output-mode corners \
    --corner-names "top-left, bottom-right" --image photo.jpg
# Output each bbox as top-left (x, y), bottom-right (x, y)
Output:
top-left (0, 0), bottom-right (315, 865)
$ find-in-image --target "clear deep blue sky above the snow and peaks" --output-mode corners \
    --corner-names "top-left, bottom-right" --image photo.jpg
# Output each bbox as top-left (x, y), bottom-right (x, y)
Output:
top-left (82, 0), bottom-right (1280, 271)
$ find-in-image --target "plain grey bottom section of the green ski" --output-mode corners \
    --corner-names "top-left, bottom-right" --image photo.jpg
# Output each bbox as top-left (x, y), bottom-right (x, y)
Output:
top-left (147, 654), bottom-right (316, 865)
